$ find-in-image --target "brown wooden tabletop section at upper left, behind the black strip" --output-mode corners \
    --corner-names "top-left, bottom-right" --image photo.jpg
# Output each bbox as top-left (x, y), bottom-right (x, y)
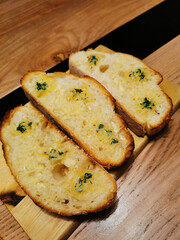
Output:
top-left (0, 0), bottom-right (163, 98)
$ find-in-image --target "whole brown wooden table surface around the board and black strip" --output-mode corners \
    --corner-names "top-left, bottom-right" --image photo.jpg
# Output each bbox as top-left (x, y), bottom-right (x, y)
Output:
top-left (0, 0), bottom-right (180, 240)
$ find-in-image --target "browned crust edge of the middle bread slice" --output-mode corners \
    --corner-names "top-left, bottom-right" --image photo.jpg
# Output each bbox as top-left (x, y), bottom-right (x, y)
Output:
top-left (21, 71), bottom-right (134, 169)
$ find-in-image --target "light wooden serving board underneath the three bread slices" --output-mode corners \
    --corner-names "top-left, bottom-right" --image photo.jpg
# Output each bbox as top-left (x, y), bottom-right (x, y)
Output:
top-left (0, 46), bottom-right (180, 240)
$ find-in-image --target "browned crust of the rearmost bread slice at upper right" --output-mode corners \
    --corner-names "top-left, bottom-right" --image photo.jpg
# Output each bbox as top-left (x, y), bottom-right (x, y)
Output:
top-left (69, 49), bottom-right (173, 137)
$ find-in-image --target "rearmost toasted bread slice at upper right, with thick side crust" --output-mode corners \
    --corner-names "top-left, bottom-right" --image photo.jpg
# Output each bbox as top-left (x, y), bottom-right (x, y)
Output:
top-left (69, 50), bottom-right (172, 136)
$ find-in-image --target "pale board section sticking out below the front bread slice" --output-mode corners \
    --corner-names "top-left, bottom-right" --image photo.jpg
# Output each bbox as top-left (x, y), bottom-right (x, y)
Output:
top-left (11, 196), bottom-right (80, 240)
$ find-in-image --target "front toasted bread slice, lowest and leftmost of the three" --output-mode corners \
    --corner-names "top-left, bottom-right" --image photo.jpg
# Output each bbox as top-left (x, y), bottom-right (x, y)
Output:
top-left (0, 106), bottom-right (116, 216)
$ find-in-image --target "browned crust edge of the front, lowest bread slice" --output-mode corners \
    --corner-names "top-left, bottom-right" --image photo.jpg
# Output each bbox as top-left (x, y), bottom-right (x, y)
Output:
top-left (0, 105), bottom-right (117, 216)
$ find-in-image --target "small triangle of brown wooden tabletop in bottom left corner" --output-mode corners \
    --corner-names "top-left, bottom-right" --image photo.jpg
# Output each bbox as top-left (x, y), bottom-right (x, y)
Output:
top-left (0, 200), bottom-right (30, 240)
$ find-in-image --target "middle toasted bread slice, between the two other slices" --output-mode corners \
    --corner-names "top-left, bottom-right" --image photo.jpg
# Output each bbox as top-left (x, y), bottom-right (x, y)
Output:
top-left (21, 72), bottom-right (133, 168)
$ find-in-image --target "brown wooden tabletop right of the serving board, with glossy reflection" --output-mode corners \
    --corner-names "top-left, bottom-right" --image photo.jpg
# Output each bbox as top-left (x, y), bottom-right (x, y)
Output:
top-left (69, 36), bottom-right (180, 240)
